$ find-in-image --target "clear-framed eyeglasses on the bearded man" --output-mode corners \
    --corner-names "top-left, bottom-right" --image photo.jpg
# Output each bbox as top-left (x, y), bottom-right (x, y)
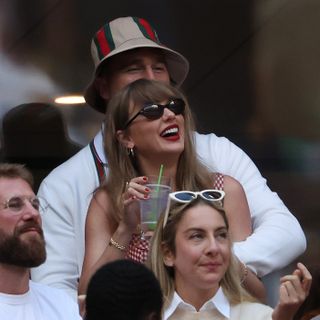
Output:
top-left (2, 196), bottom-right (48, 214)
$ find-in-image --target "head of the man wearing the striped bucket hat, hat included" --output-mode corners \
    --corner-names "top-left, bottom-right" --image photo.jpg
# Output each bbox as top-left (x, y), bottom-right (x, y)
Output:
top-left (85, 17), bottom-right (189, 113)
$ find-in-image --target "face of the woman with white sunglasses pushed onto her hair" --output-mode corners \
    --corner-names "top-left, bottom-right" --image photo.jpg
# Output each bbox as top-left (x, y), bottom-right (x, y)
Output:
top-left (165, 204), bottom-right (231, 300)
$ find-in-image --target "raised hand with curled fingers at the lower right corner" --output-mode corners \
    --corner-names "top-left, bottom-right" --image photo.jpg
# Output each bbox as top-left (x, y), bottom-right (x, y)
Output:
top-left (272, 262), bottom-right (312, 320)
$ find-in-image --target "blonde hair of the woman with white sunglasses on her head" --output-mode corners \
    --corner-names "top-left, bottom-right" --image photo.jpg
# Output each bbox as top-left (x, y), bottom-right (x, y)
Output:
top-left (148, 198), bottom-right (256, 308)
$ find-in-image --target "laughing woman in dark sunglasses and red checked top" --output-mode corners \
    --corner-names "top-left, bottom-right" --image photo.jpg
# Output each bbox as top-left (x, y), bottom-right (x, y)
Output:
top-left (79, 79), bottom-right (264, 298)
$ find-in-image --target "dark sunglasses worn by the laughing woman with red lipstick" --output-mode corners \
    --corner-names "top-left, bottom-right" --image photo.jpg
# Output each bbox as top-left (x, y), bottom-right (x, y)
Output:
top-left (123, 98), bottom-right (185, 130)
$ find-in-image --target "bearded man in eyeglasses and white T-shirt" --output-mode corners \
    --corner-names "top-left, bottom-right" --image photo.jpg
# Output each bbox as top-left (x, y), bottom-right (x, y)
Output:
top-left (0, 163), bottom-right (81, 320)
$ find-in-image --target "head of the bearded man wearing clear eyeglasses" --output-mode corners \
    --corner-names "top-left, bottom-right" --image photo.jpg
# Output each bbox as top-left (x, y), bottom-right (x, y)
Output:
top-left (0, 163), bottom-right (46, 269)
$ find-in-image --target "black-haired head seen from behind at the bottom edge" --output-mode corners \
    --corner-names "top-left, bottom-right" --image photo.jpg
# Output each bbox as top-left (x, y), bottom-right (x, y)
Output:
top-left (85, 260), bottom-right (162, 320)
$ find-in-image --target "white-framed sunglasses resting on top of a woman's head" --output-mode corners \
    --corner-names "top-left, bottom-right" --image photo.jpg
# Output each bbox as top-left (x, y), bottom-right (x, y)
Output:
top-left (163, 189), bottom-right (225, 228)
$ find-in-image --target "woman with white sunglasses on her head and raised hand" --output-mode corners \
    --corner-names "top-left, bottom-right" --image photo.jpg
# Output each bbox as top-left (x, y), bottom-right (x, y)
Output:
top-left (150, 196), bottom-right (311, 320)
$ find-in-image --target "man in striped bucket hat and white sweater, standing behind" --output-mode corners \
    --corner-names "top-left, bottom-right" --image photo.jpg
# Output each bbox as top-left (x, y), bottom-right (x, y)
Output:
top-left (32, 17), bottom-right (306, 298)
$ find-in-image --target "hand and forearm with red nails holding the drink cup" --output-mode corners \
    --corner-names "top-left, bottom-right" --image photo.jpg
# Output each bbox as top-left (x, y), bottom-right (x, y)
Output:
top-left (121, 176), bottom-right (150, 230)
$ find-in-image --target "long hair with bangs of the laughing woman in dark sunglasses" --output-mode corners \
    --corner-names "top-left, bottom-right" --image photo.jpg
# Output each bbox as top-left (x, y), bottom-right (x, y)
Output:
top-left (102, 79), bottom-right (213, 222)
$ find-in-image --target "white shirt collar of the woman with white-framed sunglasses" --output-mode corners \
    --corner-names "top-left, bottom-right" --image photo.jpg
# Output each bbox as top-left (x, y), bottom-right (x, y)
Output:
top-left (163, 287), bottom-right (230, 320)
